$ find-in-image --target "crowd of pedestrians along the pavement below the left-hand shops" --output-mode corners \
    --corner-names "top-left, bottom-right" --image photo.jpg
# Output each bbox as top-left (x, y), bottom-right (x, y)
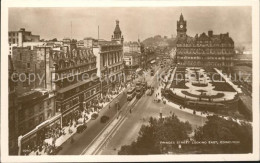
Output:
top-left (22, 85), bottom-right (125, 155)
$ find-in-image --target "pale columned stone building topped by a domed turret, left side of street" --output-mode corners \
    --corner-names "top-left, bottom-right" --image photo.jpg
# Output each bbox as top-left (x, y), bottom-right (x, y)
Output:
top-left (93, 20), bottom-right (125, 95)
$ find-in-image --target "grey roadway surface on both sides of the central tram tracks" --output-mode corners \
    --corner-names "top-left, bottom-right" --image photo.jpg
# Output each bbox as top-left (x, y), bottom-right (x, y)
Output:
top-left (58, 63), bottom-right (206, 155)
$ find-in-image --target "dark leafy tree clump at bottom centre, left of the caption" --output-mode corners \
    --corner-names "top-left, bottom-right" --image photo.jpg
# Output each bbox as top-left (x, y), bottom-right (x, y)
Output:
top-left (118, 114), bottom-right (192, 155)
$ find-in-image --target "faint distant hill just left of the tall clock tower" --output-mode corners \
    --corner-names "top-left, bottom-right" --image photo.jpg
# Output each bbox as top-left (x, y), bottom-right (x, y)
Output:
top-left (142, 35), bottom-right (176, 47)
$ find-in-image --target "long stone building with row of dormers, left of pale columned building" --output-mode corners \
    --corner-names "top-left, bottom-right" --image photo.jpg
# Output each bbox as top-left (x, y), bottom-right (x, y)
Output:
top-left (50, 48), bottom-right (101, 126)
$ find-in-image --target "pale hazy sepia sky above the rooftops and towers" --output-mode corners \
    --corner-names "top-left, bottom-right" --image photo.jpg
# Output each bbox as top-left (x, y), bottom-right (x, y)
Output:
top-left (8, 6), bottom-right (252, 43)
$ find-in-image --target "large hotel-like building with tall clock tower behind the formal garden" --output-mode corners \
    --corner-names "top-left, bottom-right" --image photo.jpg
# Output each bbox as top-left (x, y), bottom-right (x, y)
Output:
top-left (176, 14), bottom-right (235, 69)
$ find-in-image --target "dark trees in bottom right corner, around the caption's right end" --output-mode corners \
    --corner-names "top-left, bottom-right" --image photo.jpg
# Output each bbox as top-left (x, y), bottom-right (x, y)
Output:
top-left (194, 116), bottom-right (252, 153)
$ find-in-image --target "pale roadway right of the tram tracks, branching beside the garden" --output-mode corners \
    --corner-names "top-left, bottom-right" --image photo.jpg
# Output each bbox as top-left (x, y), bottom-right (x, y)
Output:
top-left (99, 64), bottom-right (206, 155)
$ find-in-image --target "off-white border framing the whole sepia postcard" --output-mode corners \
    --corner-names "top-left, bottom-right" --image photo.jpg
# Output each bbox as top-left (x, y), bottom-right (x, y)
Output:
top-left (1, 0), bottom-right (259, 162)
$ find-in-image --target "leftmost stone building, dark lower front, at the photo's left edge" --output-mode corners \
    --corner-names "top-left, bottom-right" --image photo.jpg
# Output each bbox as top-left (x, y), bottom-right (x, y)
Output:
top-left (9, 46), bottom-right (59, 154)
